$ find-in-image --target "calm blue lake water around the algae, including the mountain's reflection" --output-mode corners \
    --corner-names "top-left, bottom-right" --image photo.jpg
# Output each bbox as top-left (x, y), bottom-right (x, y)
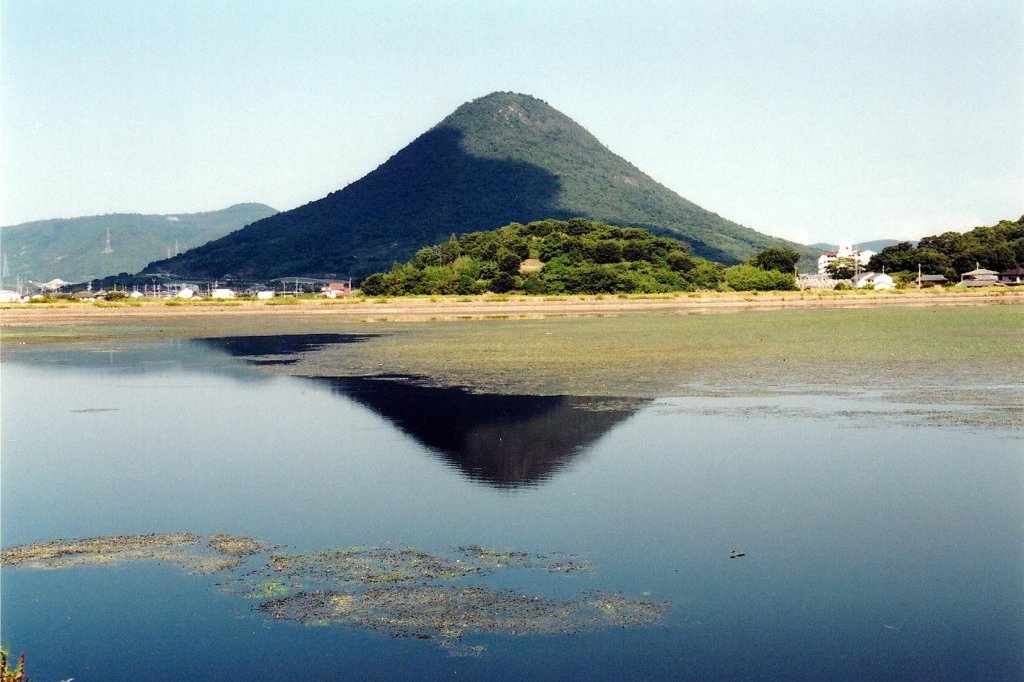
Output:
top-left (0, 335), bottom-right (1024, 682)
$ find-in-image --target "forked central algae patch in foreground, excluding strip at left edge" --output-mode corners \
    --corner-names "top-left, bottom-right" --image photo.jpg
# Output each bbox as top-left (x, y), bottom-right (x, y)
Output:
top-left (253, 545), bottom-right (666, 645)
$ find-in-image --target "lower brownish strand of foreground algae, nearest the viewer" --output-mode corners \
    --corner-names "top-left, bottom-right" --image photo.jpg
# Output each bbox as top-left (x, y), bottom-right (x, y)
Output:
top-left (259, 585), bottom-right (666, 641)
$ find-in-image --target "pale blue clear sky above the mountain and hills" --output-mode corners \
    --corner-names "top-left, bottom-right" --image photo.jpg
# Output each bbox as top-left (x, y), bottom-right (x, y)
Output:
top-left (0, 0), bottom-right (1024, 243)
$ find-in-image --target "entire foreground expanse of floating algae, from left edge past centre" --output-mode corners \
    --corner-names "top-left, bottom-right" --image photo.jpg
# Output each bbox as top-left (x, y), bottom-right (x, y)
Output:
top-left (0, 532), bottom-right (666, 655)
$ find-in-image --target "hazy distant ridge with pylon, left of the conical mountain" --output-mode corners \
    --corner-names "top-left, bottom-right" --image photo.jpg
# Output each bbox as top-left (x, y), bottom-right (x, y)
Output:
top-left (0, 204), bottom-right (278, 286)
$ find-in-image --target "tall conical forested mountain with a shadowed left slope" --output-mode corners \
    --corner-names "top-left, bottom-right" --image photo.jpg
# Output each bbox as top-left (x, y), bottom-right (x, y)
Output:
top-left (146, 92), bottom-right (812, 278)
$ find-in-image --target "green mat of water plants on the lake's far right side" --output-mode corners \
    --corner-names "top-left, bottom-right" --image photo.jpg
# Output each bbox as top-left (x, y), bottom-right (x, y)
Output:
top-left (290, 305), bottom-right (1024, 397)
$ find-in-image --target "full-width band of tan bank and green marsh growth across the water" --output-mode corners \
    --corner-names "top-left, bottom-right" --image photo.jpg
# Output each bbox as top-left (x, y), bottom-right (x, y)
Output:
top-left (3, 291), bottom-right (1024, 404)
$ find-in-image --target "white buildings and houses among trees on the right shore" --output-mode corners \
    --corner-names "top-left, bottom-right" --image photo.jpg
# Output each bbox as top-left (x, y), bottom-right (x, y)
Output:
top-left (797, 244), bottom-right (1024, 290)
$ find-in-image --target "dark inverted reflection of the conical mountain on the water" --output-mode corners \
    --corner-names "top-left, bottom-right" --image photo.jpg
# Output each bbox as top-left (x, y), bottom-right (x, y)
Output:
top-left (201, 334), bottom-right (649, 487)
